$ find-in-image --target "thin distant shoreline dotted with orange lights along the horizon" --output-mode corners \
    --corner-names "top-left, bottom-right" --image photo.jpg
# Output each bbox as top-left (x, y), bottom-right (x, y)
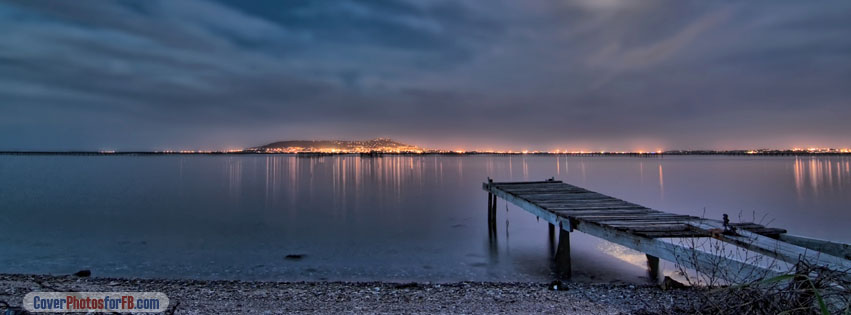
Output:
top-left (0, 150), bottom-right (851, 157)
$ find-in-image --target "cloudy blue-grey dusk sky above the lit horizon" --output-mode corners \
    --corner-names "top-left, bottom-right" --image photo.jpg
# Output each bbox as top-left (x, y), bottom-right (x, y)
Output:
top-left (0, 0), bottom-right (851, 151)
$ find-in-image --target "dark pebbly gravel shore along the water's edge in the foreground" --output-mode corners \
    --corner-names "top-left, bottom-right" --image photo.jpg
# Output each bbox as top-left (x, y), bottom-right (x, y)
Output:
top-left (0, 274), bottom-right (697, 314)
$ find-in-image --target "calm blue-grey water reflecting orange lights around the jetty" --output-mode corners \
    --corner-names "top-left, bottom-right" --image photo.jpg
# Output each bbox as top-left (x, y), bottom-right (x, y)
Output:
top-left (0, 155), bottom-right (851, 282)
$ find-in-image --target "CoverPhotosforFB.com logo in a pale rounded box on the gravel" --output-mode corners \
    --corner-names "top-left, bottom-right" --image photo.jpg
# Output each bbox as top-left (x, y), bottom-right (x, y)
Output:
top-left (23, 292), bottom-right (168, 313)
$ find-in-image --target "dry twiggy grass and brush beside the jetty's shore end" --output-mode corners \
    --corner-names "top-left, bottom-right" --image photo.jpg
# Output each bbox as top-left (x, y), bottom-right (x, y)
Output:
top-left (676, 212), bottom-right (851, 315)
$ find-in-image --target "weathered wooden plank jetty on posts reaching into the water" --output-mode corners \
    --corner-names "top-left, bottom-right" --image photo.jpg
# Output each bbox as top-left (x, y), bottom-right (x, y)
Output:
top-left (482, 178), bottom-right (851, 281)
